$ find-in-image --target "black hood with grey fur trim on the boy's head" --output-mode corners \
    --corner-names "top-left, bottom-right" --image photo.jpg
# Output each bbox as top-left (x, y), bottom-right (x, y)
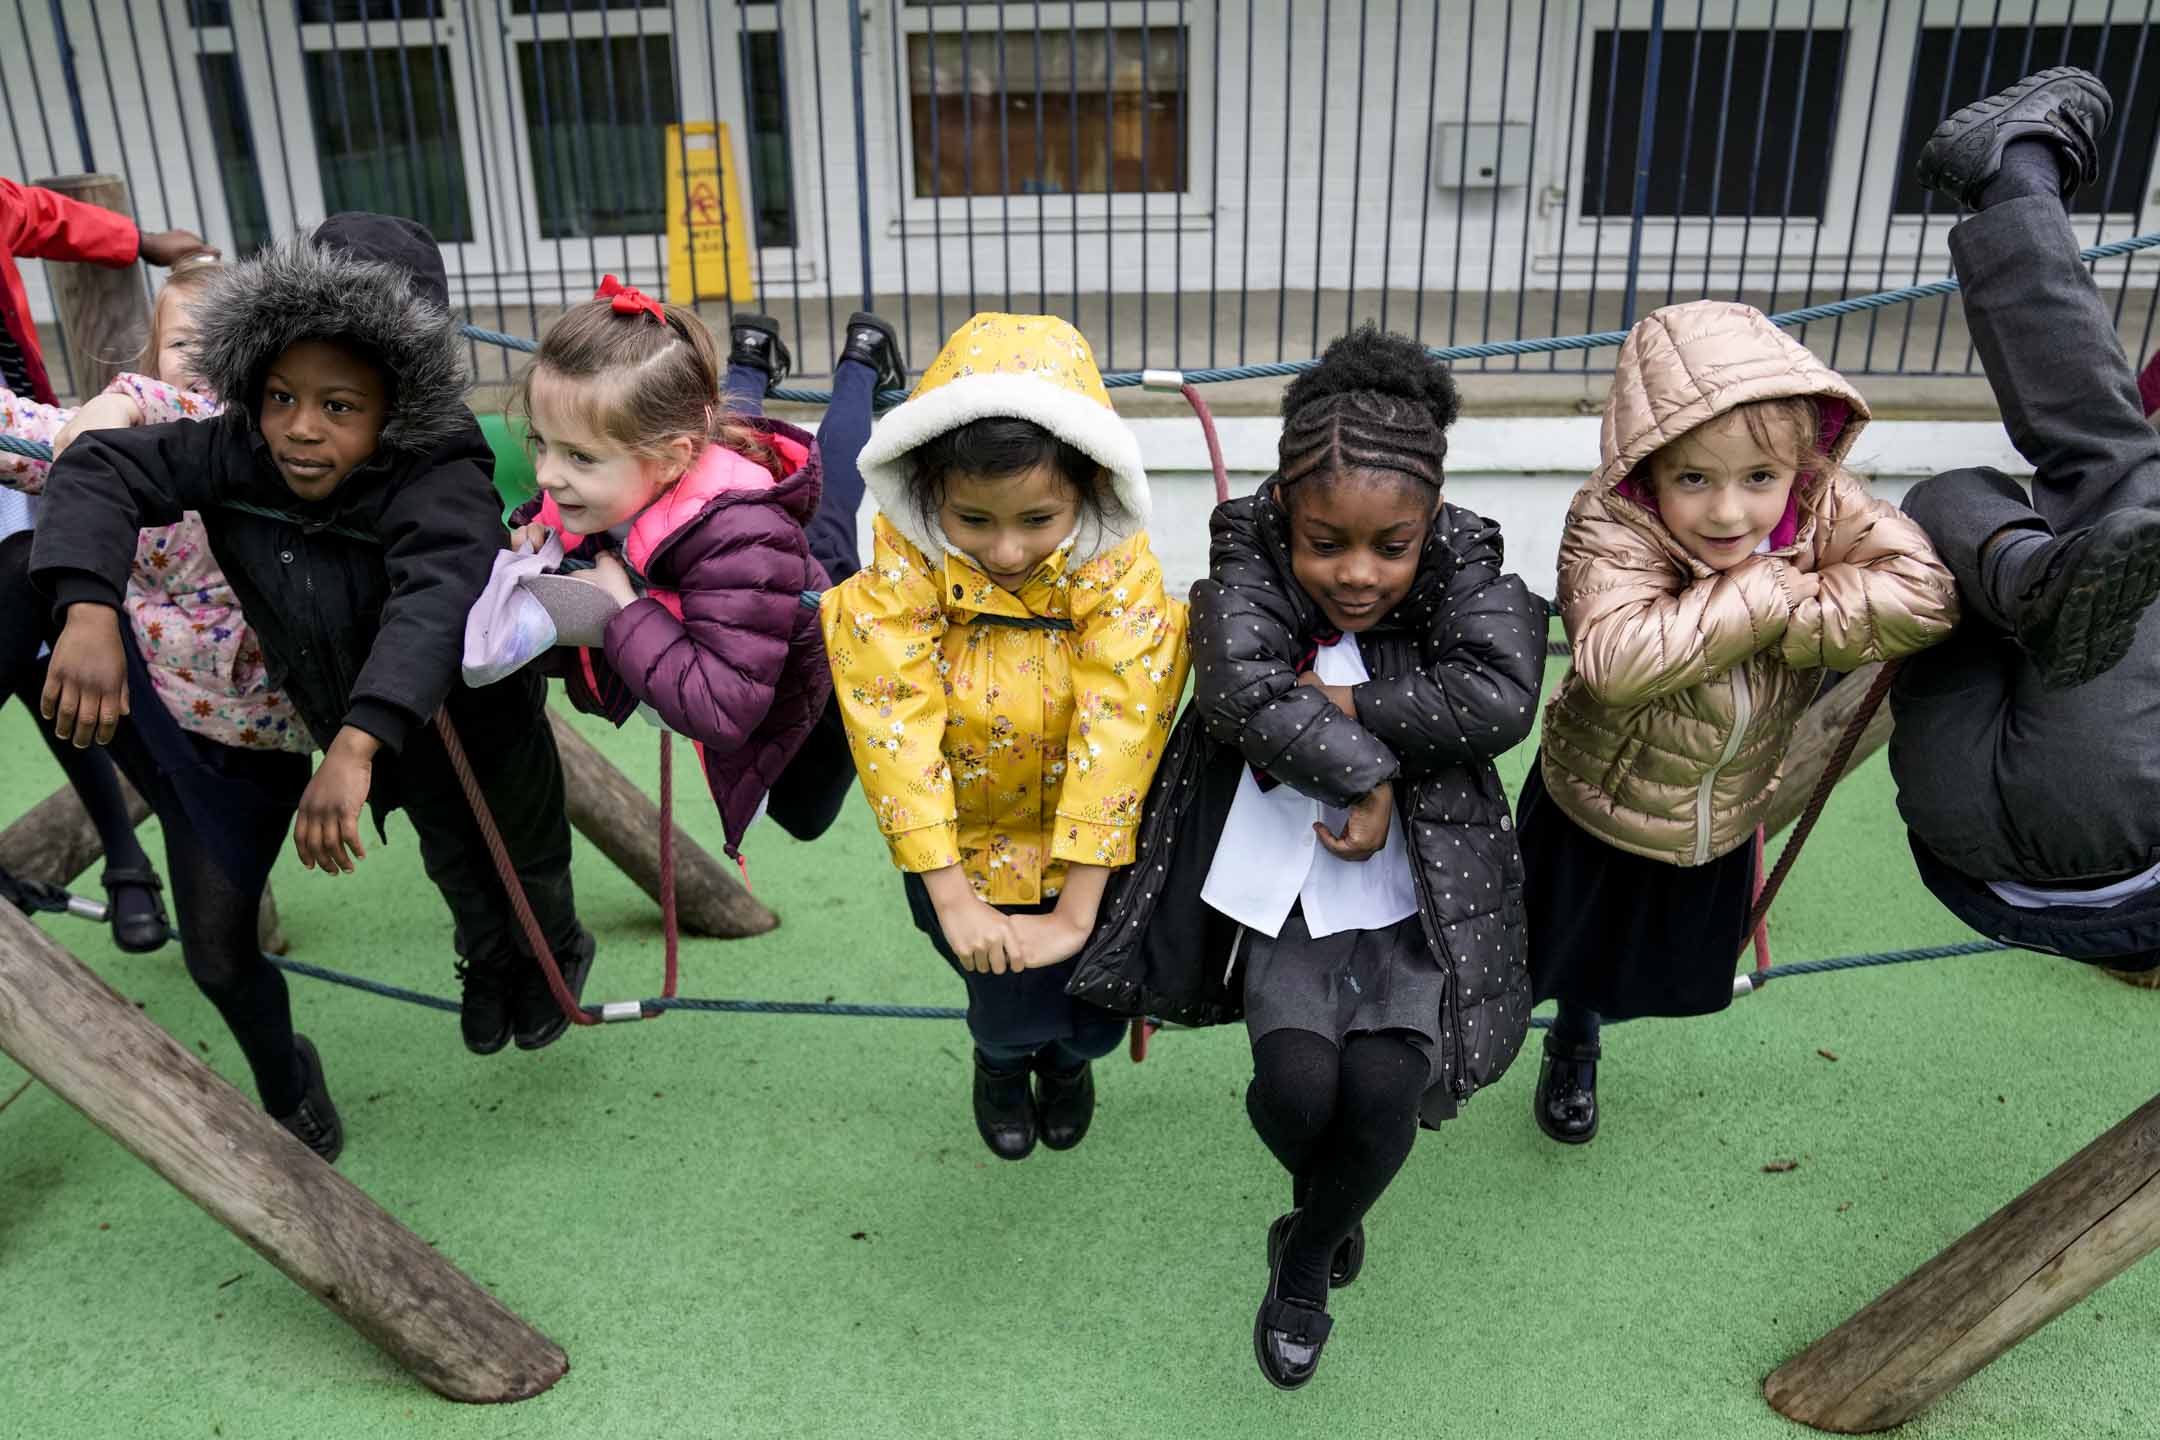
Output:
top-left (194, 214), bottom-right (473, 456)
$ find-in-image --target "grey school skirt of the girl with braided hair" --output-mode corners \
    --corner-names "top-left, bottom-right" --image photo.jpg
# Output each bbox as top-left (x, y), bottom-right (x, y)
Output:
top-left (1240, 909), bottom-right (1447, 1051)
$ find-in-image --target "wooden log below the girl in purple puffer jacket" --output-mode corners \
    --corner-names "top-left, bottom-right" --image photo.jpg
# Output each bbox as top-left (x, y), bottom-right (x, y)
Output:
top-left (549, 710), bottom-right (780, 939)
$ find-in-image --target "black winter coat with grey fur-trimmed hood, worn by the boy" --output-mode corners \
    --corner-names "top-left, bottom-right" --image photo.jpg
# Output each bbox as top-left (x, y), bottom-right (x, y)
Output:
top-left (30, 216), bottom-right (503, 751)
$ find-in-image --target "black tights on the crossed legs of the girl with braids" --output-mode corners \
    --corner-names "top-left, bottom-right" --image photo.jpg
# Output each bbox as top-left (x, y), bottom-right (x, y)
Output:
top-left (1244, 1030), bottom-right (1432, 1302)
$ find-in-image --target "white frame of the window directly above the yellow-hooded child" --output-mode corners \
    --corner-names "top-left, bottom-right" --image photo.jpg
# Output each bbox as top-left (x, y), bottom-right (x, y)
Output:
top-left (881, 0), bottom-right (1220, 237)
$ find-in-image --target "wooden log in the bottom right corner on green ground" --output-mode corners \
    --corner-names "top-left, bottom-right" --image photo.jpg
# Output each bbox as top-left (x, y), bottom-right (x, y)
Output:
top-left (1763, 1095), bottom-right (2160, 1434)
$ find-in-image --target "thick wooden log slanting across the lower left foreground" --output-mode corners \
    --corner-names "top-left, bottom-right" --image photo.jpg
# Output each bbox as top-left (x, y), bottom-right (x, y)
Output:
top-left (0, 907), bottom-right (570, 1403)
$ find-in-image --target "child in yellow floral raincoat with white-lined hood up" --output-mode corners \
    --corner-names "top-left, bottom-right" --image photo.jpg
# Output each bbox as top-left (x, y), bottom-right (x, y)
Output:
top-left (823, 315), bottom-right (1188, 1159)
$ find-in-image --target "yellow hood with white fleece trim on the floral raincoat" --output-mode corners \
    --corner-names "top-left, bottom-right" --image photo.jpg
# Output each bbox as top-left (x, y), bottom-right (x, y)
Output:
top-left (858, 313), bottom-right (1153, 566)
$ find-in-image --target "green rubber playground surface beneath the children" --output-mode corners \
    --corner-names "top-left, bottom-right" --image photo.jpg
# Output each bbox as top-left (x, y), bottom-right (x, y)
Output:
top-left (0, 664), bottom-right (2160, 1440)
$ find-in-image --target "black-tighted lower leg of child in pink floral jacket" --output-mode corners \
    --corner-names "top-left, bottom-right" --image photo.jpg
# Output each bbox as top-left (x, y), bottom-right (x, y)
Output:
top-left (158, 805), bottom-right (305, 1114)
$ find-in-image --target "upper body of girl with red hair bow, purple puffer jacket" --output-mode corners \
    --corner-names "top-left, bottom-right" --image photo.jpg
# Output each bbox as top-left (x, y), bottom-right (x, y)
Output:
top-left (516, 287), bottom-right (832, 855)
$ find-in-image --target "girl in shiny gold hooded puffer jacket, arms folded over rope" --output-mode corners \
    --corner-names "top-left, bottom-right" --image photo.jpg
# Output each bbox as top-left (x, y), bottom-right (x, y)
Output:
top-left (1521, 300), bottom-right (1957, 1144)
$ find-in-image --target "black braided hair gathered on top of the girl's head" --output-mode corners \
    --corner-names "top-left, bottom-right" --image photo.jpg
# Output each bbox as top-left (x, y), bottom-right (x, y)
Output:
top-left (1277, 322), bottom-right (1462, 503)
